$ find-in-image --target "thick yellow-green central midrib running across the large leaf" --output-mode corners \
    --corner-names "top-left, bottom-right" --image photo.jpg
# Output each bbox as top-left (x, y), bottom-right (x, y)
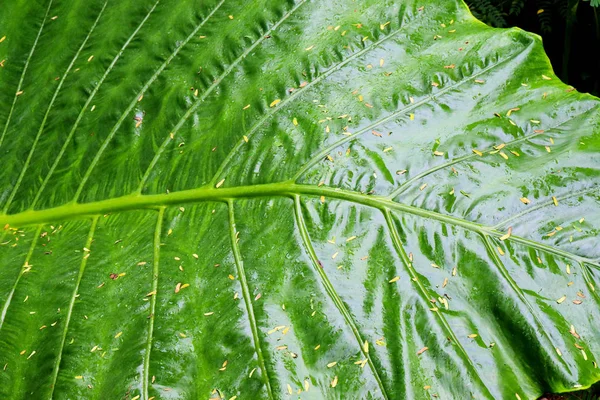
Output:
top-left (0, 181), bottom-right (600, 268)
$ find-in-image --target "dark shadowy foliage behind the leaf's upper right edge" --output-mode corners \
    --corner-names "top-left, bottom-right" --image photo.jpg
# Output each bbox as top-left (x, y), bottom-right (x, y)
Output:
top-left (466, 0), bottom-right (600, 96)
